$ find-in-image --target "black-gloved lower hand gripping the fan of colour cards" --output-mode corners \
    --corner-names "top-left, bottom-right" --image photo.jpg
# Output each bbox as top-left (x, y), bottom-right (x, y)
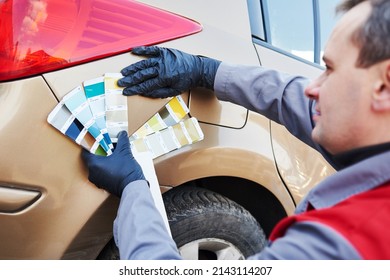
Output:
top-left (81, 131), bottom-right (145, 197)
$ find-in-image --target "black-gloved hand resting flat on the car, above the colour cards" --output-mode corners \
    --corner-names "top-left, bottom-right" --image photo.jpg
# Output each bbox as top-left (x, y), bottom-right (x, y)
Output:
top-left (118, 46), bottom-right (221, 98)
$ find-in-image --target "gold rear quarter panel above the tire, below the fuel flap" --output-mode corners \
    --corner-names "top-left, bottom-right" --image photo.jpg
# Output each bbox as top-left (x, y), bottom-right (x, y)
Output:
top-left (155, 112), bottom-right (295, 214)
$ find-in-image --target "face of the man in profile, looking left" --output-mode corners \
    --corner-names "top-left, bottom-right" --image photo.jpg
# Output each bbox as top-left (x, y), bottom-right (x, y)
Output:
top-left (305, 2), bottom-right (375, 154)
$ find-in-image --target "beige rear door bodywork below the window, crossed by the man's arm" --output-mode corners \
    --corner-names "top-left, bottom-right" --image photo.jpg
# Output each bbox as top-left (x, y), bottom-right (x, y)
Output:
top-left (256, 45), bottom-right (335, 203)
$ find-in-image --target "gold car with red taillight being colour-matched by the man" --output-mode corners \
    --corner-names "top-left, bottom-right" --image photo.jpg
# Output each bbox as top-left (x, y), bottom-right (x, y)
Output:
top-left (0, 0), bottom-right (337, 260)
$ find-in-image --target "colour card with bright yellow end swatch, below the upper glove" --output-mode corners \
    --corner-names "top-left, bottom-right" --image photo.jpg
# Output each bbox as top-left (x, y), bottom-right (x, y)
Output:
top-left (130, 96), bottom-right (190, 140)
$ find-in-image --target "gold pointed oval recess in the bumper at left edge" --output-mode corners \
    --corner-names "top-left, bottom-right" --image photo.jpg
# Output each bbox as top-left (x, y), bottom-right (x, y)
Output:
top-left (0, 185), bottom-right (41, 213)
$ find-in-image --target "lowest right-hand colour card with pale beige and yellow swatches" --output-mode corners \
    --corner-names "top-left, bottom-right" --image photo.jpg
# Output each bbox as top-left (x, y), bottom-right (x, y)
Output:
top-left (130, 118), bottom-right (204, 159)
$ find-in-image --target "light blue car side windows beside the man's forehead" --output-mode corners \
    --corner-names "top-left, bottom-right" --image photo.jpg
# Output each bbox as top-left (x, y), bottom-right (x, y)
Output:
top-left (248, 0), bottom-right (339, 64)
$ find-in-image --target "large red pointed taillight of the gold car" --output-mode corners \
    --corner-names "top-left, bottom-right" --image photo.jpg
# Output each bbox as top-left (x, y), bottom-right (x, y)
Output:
top-left (0, 0), bottom-right (201, 81)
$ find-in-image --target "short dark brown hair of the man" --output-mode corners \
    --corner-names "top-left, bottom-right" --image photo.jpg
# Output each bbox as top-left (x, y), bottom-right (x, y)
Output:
top-left (337, 0), bottom-right (390, 68)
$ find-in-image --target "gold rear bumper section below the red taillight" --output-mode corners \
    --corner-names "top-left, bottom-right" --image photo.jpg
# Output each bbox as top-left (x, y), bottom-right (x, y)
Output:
top-left (0, 77), bottom-right (112, 259)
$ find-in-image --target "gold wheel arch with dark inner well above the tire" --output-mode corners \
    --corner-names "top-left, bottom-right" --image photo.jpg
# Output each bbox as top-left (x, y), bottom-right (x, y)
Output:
top-left (155, 147), bottom-right (295, 236)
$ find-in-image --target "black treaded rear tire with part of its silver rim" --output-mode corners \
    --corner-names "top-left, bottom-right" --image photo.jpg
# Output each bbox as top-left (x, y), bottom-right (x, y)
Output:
top-left (163, 186), bottom-right (266, 259)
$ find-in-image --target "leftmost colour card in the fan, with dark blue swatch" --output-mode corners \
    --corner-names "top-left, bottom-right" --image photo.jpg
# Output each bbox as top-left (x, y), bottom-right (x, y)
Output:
top-left (47, 102), bottom-right (106, 155)
